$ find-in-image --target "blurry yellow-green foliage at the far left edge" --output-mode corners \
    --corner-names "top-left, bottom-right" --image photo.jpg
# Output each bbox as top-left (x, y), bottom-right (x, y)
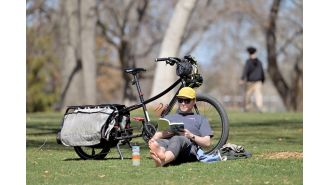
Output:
top-left (26, 28), bottom-right (60, 112)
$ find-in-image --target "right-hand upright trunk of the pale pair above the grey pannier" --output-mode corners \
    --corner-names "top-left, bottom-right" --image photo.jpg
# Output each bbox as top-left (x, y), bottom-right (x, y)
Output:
top-left (80, 0), bottom-right (96, 104)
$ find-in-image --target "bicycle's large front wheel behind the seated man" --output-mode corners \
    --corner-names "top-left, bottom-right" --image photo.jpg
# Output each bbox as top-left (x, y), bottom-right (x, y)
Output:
top-left (193, 94), bottom-right (229, 154)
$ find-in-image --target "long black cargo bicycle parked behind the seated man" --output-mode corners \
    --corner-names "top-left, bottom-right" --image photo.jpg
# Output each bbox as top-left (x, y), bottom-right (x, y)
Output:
top-left (57, 55), bottom-right (229, 159)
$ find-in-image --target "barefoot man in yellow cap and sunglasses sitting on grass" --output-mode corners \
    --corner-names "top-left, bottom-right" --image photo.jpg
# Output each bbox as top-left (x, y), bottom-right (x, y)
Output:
top-left (149, 87), bottom-right (212, 167)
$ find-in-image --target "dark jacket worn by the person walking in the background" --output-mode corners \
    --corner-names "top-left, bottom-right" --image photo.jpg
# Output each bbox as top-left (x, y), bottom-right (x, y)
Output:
top-left (241, 58), bottom-right (265, 83)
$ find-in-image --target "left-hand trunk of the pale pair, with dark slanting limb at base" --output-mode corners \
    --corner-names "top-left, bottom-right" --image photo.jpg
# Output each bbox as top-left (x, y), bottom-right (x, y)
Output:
top-left (57, 0), bottom-right (84, 109)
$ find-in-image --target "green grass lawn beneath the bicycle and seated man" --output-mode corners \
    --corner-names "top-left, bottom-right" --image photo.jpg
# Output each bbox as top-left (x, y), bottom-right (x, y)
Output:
top-left (26, 112), bottom-right (303, 185)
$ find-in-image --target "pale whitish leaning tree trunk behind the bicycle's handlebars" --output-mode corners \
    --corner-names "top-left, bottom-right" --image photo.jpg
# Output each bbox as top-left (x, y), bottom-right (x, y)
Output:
top-left (151, 0), bottom-right (196, 105)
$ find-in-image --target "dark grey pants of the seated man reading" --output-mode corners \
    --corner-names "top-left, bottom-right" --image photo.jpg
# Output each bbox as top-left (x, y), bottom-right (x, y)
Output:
top-left (157, 136), bottom-right (197, 164)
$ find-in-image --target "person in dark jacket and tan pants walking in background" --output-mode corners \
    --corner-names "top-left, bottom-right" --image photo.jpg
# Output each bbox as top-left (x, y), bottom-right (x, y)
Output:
top-left (240, 46), bottom-right (265, 112)
